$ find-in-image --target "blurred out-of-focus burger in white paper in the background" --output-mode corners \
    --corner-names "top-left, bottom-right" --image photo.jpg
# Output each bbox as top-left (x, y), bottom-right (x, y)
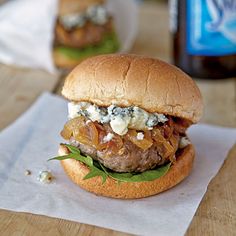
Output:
top-left (53, 0), bottom-right (119, 69)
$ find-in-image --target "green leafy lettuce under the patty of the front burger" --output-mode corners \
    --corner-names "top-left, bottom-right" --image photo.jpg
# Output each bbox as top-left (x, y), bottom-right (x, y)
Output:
top-left (49, 144), bottom-right (171, 183)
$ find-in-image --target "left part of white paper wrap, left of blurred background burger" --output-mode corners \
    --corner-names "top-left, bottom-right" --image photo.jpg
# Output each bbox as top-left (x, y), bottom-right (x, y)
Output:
top-left (0, 0), bottom-right (57, 72)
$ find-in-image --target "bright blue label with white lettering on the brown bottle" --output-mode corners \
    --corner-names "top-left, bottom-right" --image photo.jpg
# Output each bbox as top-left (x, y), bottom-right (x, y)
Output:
top-left (186, 0), bottom-right (236, 56)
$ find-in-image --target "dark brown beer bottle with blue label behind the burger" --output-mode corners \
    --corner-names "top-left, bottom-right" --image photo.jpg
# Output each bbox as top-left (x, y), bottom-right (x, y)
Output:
top-left (170, 0), bottom-right (236, 79)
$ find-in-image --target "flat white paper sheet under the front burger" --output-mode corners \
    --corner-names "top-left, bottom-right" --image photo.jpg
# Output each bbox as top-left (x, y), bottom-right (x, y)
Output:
top-left (0, 94), bottom-right (236, 235)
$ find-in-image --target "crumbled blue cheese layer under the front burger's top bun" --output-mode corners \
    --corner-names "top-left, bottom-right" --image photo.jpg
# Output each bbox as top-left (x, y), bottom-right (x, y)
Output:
top-left (68, 102), bottom-right (168, 135)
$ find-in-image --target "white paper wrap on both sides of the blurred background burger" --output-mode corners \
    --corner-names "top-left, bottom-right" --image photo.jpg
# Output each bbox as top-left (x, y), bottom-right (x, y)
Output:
top-left (0, 0), bottom-right (138, 73)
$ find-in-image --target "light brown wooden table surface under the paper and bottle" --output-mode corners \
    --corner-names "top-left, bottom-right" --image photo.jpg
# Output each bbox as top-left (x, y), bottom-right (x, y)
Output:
top-left (0, 3), bottom-right (236, 236)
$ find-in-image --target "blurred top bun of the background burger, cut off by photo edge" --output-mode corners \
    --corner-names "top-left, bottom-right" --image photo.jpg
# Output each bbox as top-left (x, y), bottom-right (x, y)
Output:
top-left (58, 0), bottom-right (104, 16)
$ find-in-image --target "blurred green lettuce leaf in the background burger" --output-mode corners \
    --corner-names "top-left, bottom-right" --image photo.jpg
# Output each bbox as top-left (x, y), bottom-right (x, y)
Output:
top-left (55, 32), bottom-right (120, 60)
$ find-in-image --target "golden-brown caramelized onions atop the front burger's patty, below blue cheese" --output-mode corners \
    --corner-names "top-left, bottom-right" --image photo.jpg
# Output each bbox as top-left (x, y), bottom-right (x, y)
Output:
top-left (61, 116), bottom-right (181, 161)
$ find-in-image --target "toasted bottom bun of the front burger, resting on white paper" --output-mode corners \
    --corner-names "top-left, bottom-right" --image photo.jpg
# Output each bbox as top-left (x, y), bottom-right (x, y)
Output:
top-left (59, 145), bottom-right (195, 199)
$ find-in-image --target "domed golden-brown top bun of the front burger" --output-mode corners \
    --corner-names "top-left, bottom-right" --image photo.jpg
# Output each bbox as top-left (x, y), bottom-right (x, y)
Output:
top-left (62, 54), bottom-right (203, 123)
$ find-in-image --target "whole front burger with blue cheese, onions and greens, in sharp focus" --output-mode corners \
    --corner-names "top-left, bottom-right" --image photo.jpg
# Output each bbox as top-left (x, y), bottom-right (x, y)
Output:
top-left (53, 54), bottom-right (203, 199)
